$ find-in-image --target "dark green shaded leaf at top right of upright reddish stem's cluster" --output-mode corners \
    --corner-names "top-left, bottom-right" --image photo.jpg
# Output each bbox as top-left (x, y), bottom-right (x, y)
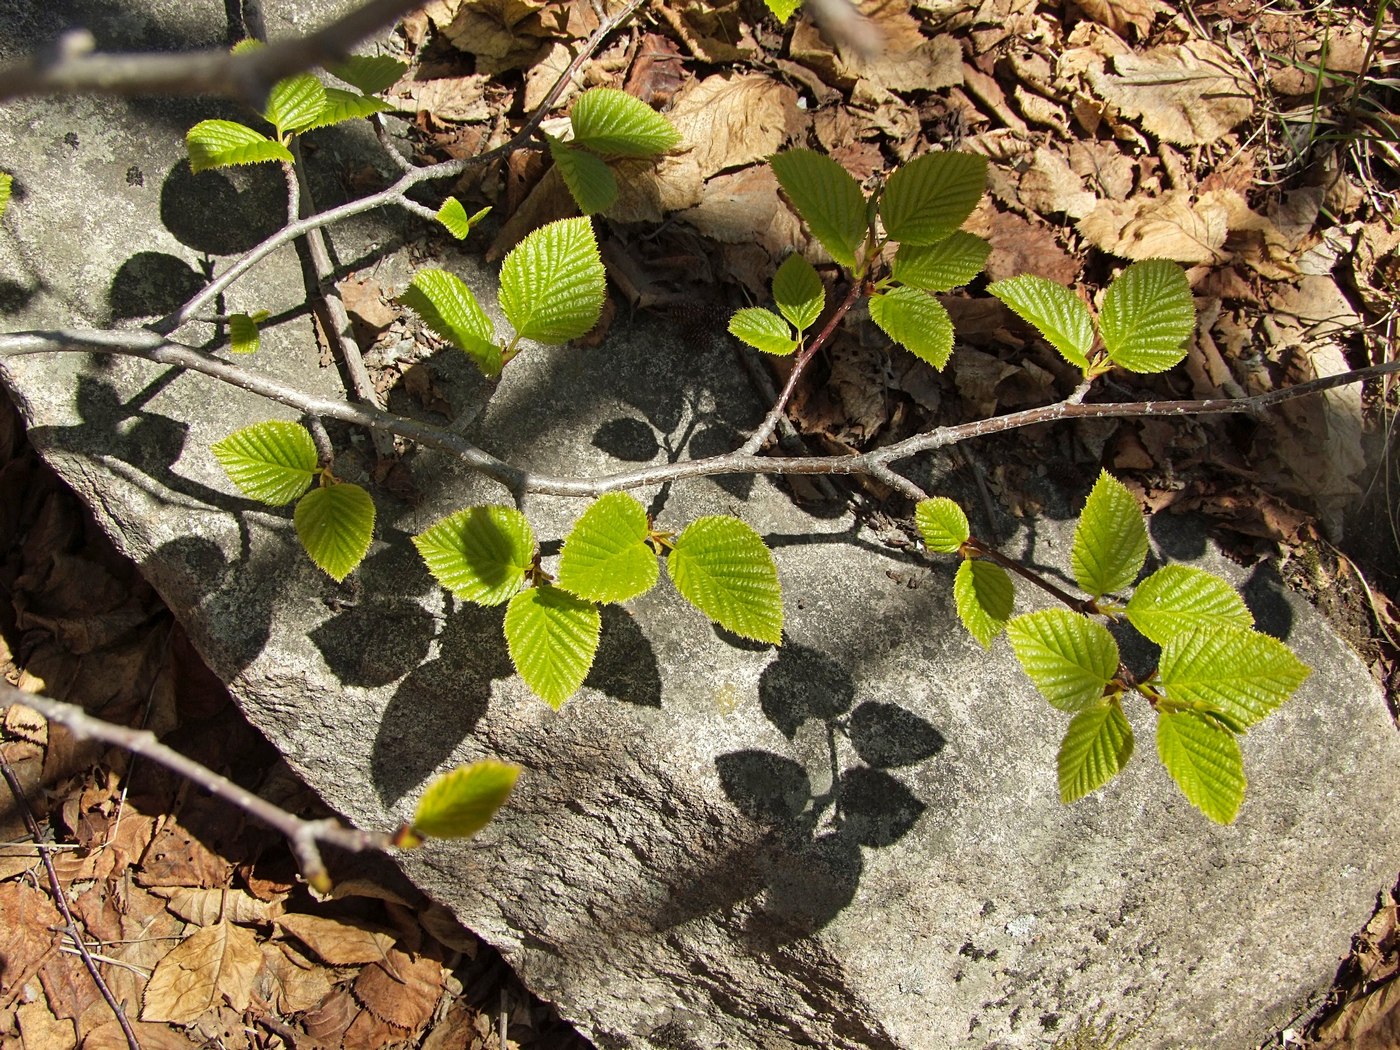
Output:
top-left (879, 153), bottom-right (987, 244)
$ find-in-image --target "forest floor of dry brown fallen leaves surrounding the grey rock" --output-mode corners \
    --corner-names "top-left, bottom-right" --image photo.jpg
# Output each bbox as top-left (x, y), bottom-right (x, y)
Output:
top-left (0, 0), bottom-right (1400, 1050)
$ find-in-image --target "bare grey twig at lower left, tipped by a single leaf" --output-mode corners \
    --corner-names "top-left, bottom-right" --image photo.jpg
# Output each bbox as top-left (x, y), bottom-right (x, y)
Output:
top-left (0, 682), bottom-right (391, 896)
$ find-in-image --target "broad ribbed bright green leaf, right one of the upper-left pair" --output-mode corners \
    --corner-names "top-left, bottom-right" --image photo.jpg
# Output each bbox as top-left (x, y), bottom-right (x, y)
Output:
top-left (501, 218), bottom-right (605, 343)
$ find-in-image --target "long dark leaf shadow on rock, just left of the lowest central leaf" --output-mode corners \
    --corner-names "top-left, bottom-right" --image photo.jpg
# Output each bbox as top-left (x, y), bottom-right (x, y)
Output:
top-left (371, 603), bottom-right (515, 806)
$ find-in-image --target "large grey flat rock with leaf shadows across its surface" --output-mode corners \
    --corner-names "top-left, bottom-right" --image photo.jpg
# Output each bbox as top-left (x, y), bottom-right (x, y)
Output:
top-left (0, 4), bottom-right (1400, 1050)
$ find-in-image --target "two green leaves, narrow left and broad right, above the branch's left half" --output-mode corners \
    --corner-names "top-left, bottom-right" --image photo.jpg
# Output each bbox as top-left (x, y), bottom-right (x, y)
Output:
top-left (399, 211), bottom-right (606, 377)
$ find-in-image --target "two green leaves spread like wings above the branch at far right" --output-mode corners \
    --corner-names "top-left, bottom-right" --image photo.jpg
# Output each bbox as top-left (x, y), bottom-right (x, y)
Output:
top-left (987, 259), bottom-right (1196, 378)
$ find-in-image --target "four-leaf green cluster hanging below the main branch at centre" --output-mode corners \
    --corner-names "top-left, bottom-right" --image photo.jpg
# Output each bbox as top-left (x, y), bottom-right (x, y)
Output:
top-left (413, 493), bottom-right (783, 708)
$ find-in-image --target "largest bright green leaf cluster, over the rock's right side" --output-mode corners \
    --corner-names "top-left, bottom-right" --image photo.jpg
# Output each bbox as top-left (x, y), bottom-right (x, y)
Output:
top-left (916, 472), bottom-right (1309, 823)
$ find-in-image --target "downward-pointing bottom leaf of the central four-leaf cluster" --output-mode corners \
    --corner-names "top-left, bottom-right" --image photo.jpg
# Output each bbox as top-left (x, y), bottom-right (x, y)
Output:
top-left (505, 585), bottom-right (602, 711)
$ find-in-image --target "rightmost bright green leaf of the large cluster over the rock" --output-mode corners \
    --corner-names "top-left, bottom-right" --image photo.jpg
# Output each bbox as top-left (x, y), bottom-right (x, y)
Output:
top-left (1156, 624), bottom-right (1312, 727)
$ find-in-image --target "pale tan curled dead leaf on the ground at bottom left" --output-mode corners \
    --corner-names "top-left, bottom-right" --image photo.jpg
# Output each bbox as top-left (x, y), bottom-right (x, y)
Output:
top-left (141, 923), bottom-right (262, 1025)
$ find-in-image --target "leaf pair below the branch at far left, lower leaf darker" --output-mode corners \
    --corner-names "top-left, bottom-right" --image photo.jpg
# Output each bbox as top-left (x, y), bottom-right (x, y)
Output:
top-left (213, 421), bottom-right (374, 582)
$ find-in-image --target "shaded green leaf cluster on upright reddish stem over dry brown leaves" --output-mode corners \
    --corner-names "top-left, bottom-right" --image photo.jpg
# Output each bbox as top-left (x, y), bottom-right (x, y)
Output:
top-left (767, 150), bottom-right (991, 368)
